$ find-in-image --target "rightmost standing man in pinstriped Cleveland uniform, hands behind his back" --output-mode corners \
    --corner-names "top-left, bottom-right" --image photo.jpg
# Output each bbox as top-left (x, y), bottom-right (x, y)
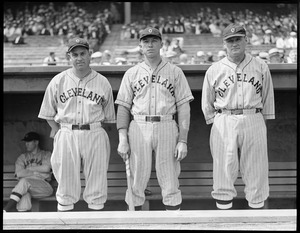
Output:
top-left (202, 24), bottom-right (275, 209)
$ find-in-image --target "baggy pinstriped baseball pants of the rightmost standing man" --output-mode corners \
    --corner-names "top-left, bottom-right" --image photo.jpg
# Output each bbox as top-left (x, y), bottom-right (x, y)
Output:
top-left (210, 113), bottom-right (269, 204)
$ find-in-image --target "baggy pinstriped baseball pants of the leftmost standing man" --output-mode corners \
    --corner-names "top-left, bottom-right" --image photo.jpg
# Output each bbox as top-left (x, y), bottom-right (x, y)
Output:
top-left (51, 126), bottom-right (110, 211)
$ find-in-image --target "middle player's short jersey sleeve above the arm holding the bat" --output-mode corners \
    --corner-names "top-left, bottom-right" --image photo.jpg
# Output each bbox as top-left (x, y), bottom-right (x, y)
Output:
top-left (115, 69), bottom-right (133, 109)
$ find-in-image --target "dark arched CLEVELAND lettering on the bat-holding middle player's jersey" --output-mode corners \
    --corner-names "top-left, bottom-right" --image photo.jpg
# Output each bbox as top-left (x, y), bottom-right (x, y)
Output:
top-left (133, 75), bottom-right (175, 96)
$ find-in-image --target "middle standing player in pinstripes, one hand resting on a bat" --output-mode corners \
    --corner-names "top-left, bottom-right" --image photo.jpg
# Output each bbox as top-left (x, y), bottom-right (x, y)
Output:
top-left (115, 28), bottom-right (194, 210)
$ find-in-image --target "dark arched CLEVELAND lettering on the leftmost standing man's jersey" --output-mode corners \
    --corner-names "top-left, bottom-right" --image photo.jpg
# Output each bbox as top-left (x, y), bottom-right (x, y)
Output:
top-left (59, 87), bottom-right (105, 105)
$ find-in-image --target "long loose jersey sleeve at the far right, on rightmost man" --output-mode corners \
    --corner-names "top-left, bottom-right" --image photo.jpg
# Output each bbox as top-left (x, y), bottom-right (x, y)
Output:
top-left (262, 63), bottom-right (275, 120)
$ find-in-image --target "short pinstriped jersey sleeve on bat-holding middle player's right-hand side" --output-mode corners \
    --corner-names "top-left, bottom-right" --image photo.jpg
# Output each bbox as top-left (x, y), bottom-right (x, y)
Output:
top-left (175, 67), bottom-right (194, 106)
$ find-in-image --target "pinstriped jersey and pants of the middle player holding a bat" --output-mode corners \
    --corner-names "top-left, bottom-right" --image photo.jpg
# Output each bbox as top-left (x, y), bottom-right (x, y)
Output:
top-left (115, 61), bottom-right (194, 206)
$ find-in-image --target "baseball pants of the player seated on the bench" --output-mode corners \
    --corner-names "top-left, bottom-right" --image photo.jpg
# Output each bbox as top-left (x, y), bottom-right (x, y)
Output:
top-left (10, 178), bottom-right (53, 211)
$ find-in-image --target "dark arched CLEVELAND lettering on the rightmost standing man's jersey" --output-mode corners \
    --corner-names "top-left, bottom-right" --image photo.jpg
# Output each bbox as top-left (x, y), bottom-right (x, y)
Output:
top-left (217, 73), bottom-right (262, 97)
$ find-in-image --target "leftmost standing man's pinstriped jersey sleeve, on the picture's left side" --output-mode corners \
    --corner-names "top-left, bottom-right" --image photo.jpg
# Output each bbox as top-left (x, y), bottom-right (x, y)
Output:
top-left (38, 78), bottom-right (57, 120)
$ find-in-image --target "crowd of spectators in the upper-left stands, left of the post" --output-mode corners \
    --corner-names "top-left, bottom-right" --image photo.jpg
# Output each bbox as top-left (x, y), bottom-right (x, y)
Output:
top-left (3, 2), bottom-right (115, 48)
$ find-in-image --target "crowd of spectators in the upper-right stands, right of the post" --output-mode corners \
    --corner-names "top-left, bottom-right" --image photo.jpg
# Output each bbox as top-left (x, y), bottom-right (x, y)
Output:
top-left (121, 4), bottom-right (297, 48)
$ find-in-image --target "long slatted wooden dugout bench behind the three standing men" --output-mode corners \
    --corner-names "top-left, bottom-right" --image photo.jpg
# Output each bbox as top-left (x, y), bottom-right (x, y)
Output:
top-left (3, 162), bottom-right (297, 211)
